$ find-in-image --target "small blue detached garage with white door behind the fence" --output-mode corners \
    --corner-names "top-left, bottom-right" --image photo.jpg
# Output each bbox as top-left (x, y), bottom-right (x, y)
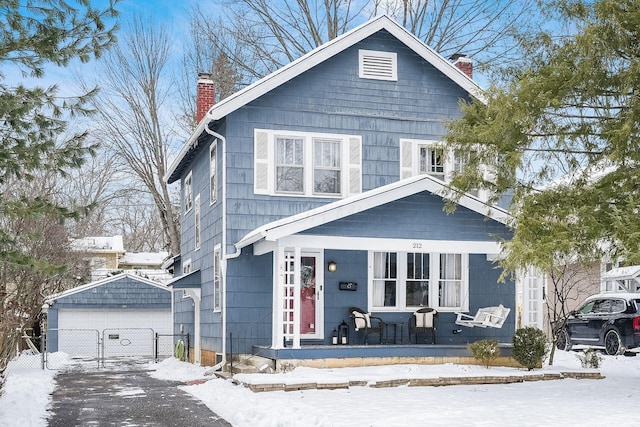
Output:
top-left (45, 274), bottom-right (172, 358)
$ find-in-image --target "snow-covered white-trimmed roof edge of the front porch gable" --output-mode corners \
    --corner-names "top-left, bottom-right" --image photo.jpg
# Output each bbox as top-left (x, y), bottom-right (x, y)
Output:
top-left (236, 175), bottom-right (511, 249)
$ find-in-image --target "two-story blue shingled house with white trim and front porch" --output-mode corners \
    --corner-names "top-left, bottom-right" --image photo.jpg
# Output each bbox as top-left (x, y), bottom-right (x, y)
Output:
top-left (167, 16), bottom-right (515, 365)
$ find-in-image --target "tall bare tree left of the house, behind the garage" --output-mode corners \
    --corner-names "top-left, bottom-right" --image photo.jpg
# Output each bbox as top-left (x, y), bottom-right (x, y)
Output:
top-left (86, 17), bottom-right (180, 254)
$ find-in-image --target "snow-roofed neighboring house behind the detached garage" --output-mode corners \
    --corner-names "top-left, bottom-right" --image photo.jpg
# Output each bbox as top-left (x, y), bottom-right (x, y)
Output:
top-left (71, 236), bottom-right (172, 283)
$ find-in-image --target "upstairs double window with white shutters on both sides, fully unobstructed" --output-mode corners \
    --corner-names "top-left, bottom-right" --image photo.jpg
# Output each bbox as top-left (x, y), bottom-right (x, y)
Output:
top-left (254, 129), bottom-right (362, 197)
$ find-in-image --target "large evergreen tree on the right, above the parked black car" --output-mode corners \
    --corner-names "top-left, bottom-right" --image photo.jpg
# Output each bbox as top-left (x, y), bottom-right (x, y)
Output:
top-left (447, 0), bottom-right (640, 271)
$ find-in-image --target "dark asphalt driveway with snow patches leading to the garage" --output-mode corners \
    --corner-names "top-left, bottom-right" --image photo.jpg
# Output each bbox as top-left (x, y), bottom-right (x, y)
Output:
top-left (48, 366), bottom-right (231, 427)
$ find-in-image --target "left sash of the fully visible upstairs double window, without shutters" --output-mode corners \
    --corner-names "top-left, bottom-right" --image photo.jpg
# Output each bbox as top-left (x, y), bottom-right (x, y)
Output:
top-left (276, 137), bottom-right (304, 193)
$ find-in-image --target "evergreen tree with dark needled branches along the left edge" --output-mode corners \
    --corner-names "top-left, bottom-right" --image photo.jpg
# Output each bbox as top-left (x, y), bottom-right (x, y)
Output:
top-left (0, 0), bottom-right (118, 372)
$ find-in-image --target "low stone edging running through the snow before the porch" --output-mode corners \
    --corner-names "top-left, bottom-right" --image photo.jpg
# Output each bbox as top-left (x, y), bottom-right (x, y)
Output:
top-left (233, 372), bottom-right (604, 393)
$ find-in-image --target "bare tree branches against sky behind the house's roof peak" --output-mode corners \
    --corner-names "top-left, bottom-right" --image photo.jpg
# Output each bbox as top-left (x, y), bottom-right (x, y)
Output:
top-left (184, 0), bottom-right (538, 89)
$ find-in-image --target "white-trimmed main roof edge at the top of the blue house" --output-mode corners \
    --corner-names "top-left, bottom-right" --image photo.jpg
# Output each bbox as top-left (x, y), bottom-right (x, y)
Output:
top-left (165, 15), bottom-right (486, 183)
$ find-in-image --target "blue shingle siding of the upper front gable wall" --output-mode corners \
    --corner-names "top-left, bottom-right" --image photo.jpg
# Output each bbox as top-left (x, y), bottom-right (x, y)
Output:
top-left (225, 31), bottom-right (468, 251)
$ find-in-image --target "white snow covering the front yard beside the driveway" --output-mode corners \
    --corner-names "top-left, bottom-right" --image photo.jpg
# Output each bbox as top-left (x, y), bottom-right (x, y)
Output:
top-left (0, 352), bottom-right (640, 427)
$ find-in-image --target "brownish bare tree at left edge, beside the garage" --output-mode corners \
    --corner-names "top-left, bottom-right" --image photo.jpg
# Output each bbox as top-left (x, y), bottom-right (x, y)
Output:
top-left (0, 176), bottom-right (88, 371)
